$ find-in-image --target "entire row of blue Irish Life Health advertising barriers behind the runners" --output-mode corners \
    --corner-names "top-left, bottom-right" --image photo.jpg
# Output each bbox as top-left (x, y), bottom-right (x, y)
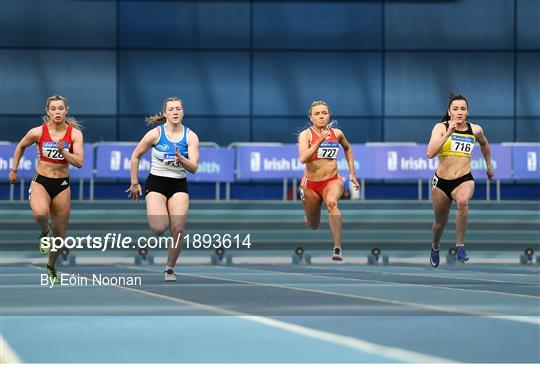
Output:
top-left (0, 142), bottom-right (540, 197)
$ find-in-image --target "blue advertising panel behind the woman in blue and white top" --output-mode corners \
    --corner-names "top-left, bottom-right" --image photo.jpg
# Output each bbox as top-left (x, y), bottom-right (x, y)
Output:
top-left (96, 142), bottom-right (234, 182)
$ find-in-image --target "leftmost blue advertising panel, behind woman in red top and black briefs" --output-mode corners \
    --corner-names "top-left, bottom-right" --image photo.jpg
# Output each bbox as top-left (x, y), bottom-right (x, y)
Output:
top-left (0, 143), bottom-right (94, 180)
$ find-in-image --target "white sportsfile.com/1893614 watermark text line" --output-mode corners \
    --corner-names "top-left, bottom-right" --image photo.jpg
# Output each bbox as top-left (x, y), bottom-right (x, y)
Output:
top-left (40, 232), bottom-right (252, 252)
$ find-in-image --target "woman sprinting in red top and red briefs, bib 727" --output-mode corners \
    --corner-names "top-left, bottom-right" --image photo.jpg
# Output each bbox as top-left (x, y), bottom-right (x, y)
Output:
top-left (298, 100), bottom-right (360, 261)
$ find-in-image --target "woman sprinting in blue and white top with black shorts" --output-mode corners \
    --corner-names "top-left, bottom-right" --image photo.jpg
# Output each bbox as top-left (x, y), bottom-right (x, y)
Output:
top-left (126, 97), bottom-right (199, 281)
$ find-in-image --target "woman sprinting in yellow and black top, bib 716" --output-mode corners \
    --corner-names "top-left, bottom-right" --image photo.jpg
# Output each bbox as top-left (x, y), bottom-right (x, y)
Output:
top-left (427, 95), bottom-right (493, 267)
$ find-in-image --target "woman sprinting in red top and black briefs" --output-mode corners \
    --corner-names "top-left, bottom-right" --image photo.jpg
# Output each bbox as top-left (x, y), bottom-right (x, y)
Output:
top-left (9, 95), bottom-right (83, 283)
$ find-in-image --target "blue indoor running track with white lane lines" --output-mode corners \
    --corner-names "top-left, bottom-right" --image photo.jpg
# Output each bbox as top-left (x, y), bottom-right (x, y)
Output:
top-left (0, 199), bottom-right (540, 363)
